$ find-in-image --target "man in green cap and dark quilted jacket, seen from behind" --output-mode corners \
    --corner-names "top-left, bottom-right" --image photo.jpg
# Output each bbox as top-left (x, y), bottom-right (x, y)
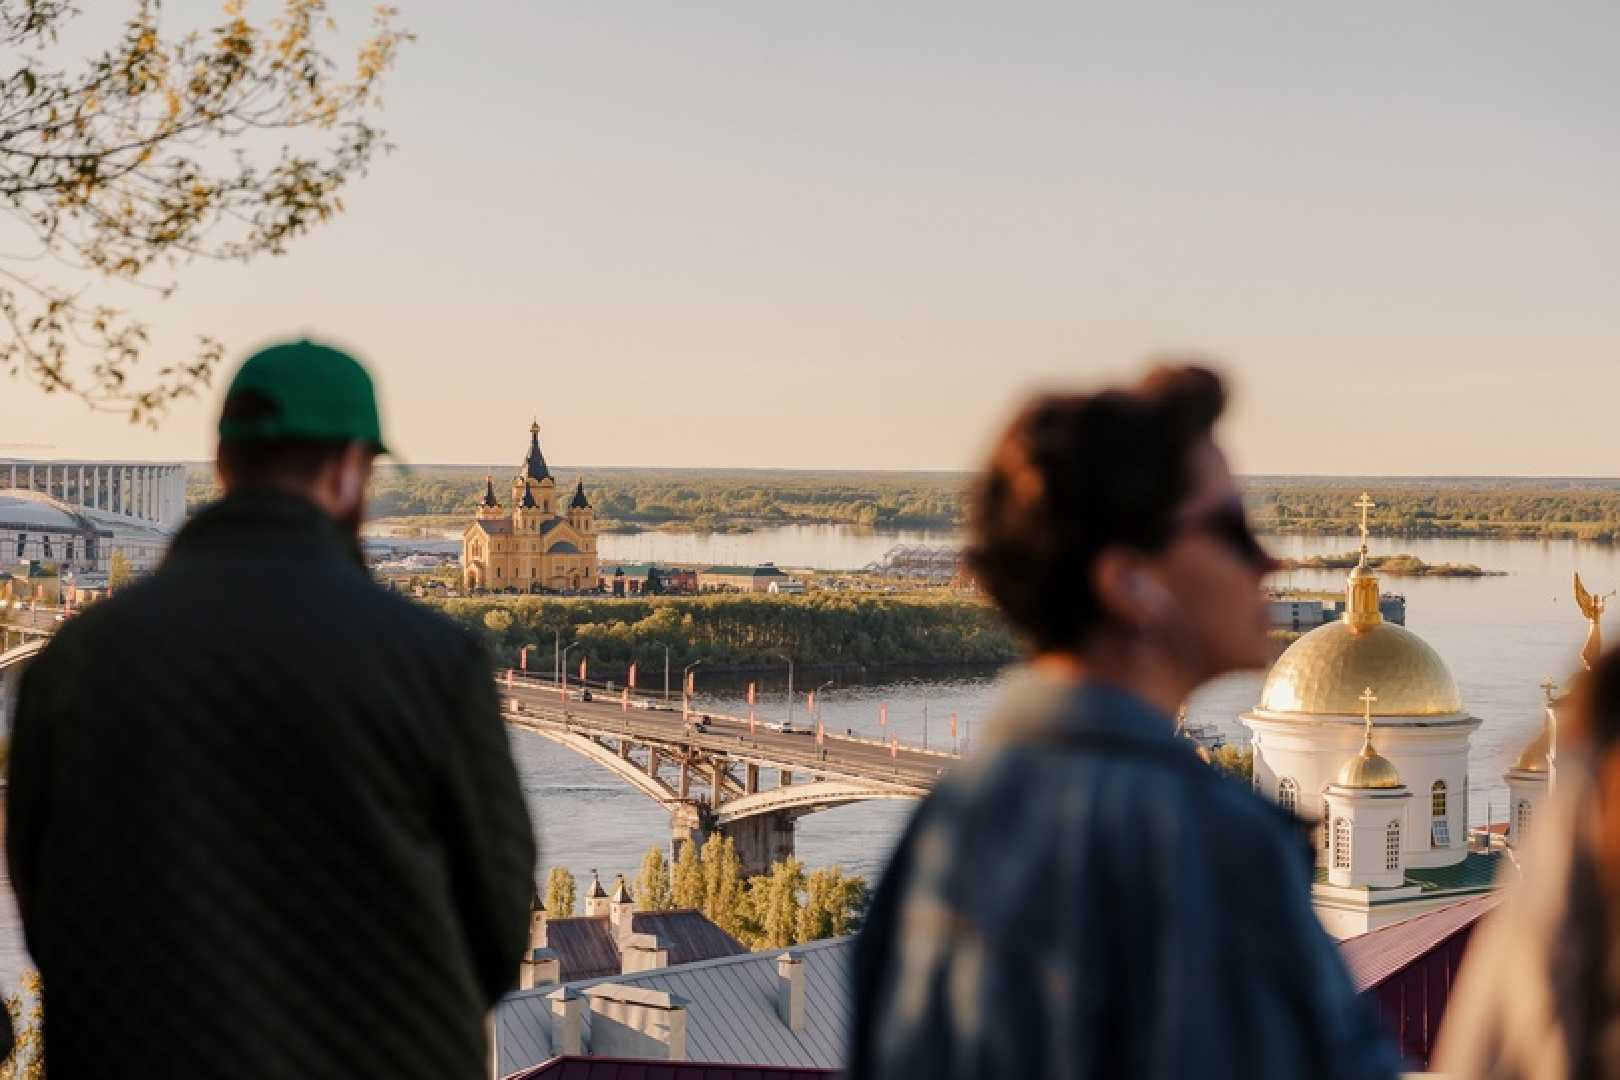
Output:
top-left (6, 342), bottom-right (535, 1080)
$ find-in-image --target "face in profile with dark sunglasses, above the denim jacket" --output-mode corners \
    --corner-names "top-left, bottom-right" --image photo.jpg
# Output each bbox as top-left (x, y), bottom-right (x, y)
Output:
top-left (1155, 439), bottom-right (1275, 678)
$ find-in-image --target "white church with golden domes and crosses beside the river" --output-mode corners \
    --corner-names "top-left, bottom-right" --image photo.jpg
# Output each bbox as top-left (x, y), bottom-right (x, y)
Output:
top-left (1241, 495), bottom-right (1552, 938)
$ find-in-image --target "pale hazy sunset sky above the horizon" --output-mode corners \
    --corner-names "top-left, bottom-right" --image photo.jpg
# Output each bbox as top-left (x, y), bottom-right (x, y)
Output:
top-left (0, 0), bottom-right (1620, 476)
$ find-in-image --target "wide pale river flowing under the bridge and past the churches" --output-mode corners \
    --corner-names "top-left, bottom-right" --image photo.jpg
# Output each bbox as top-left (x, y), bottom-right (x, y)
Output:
top-left (0, 526), bottom-right (1620, 984)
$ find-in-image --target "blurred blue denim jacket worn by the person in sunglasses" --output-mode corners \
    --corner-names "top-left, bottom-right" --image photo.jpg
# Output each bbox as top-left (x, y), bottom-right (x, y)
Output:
top-left (851, 674), bottom-right (1398, 1080)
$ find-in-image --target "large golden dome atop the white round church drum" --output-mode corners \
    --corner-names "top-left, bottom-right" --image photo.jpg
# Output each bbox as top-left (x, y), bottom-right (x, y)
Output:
top-left (1257, 620), bottom-right (1463, 718)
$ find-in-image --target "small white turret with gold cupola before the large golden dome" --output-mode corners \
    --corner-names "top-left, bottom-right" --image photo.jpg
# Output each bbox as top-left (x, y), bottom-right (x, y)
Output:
top-left (1325, 687), bottom-right (1411, 889)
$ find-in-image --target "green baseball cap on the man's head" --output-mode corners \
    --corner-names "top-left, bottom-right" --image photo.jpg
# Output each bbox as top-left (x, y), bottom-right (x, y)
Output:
top-left (219, 338), bottom-right (387, 453)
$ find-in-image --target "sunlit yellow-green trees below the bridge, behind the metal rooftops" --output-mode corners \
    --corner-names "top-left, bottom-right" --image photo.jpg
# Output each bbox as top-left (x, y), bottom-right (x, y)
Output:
top-left (544, 836), bottom-right (868, 949)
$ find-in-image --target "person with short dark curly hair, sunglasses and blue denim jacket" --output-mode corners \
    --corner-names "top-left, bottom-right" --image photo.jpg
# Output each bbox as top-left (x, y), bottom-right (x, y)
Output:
top-left (849, 366), bottom-right (1398, 1080)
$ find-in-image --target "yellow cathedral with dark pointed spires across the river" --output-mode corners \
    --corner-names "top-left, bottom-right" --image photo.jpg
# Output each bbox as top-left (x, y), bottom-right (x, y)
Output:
top-left (462, 423), bottom-right (598, 593)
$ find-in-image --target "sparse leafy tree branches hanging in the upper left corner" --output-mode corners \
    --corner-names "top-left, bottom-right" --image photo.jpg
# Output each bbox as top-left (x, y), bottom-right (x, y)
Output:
top-left (0, 0), bottom-right (408, 423)
